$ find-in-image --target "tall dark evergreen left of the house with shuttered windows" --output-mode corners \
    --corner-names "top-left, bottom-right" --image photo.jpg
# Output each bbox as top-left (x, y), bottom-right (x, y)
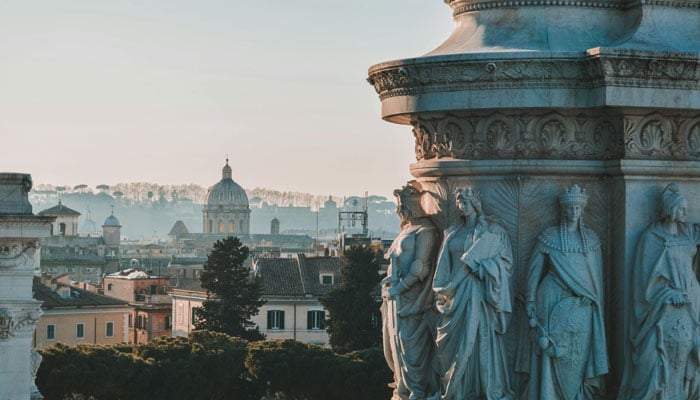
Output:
top-left (195, 236), bottom-right (265, 340)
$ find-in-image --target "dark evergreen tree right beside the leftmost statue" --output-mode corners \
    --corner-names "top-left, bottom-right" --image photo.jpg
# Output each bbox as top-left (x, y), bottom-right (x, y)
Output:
top-left (321, 246), bottom-right (381, 353)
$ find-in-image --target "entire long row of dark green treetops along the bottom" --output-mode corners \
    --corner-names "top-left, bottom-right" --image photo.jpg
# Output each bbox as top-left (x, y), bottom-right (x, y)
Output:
top-left (36, 331), bottom-right (392, 400)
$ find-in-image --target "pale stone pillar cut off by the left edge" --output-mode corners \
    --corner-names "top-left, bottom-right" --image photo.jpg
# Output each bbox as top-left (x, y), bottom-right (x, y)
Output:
top-left (0, 173), bottom-right (54, 400)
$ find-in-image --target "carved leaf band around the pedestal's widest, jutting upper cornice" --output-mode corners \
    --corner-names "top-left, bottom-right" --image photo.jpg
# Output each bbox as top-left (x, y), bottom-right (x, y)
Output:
top-left (368, 52), bottom-right (700, 100)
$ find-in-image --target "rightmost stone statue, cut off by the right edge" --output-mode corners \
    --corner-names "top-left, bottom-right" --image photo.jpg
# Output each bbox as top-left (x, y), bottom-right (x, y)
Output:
top-left (618, 183), bottom-right (700, 400)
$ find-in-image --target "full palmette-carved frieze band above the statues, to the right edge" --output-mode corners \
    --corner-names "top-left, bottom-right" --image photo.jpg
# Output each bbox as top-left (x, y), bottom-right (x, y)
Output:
top-left (413, 110), bottom-right (700, 161)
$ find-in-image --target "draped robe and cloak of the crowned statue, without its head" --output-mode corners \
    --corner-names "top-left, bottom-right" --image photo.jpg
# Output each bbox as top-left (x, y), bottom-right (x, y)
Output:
top-left (516, 226), bottom-right (608, 400)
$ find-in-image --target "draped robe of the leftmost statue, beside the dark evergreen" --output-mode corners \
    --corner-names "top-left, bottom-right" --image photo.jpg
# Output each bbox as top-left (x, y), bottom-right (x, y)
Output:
top-left (381, 224), bottom-right (438, 400)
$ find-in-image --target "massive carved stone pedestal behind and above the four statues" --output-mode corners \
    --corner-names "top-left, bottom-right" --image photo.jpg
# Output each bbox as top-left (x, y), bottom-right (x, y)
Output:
top-left (368, 0), bottom-right (700, 399)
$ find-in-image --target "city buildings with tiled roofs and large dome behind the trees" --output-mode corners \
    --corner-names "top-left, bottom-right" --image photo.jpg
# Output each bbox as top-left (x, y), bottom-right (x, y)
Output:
top-left (28, 160), bottom-right (388, 348)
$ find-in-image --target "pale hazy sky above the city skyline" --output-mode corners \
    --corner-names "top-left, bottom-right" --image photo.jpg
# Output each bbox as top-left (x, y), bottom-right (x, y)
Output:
top-left (0, 0), bottom-right (452, 196)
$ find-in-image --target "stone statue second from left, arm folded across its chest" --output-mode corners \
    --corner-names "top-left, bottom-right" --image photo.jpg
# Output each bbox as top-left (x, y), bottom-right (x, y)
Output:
top-left (433, 187), bottom-right (513, 400)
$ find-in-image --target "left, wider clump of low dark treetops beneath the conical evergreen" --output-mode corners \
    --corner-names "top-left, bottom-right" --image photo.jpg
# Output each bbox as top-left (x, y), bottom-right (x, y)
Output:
top-left (36, 331), bottom-right (259, 400)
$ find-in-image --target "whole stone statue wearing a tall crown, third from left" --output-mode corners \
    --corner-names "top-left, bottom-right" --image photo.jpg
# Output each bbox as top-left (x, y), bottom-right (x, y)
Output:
top-left (516, 185), bottom-right (608, 400)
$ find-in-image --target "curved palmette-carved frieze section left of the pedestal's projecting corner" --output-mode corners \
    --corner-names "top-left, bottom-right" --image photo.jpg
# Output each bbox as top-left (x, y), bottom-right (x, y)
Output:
top-left (413, 112), bottom-right (623, 161)
